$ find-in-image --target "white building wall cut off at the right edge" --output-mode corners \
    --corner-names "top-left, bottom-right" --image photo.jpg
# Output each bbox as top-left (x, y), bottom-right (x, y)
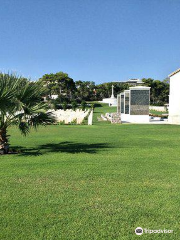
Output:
top-left (168, 68), bottom-right (180, 124)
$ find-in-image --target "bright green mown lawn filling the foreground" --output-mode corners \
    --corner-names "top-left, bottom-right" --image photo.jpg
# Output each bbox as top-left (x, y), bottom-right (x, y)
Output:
top-left (0, 106), bottom-right (180, 240)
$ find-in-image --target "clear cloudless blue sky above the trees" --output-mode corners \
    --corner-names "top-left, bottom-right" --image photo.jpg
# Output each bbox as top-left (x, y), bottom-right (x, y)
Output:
top-left (0, 0), bottom-right (180, 83)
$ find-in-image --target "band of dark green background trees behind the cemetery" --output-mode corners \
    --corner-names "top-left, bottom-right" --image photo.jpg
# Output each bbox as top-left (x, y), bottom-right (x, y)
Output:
top-left (39, 72), bottom-right (169, 105)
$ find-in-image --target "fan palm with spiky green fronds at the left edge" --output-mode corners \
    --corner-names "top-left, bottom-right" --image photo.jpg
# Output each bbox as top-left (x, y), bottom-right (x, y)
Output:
top-left (0, 73), bottom-right (53, 153)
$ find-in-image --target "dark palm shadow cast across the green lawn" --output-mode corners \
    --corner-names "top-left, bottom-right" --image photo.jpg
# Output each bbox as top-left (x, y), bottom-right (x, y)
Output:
top-left (13, 142), bottom-right (110, 156)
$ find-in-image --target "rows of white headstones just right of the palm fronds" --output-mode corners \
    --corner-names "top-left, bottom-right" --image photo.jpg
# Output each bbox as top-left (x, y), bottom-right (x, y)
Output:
top-left (51, 109), bottom-right (90, 124)
